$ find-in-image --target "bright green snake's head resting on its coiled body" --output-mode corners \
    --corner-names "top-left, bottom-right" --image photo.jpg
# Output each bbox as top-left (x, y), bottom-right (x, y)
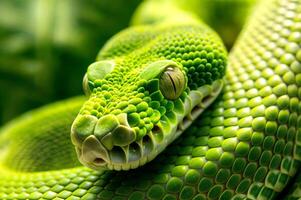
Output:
top-left (71, 23), bottom-right (226, 170)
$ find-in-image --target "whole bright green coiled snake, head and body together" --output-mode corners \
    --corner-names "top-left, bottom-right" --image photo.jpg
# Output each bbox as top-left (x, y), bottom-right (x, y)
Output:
top-left (0, 0), bottom-right (301, 200)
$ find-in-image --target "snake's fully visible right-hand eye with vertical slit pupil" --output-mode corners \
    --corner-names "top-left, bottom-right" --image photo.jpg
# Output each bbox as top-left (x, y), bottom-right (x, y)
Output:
top-left (159, 66), bottom-right (186, 100)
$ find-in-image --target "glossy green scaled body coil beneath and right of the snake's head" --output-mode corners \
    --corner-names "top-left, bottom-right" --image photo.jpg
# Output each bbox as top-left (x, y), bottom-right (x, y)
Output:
top-left (0, 0), bottom-right (301, 200)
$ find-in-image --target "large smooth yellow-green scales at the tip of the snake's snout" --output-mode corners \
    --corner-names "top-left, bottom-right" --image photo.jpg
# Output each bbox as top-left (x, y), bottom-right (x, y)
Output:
top-left (71, 113), bottom-right (136, 169)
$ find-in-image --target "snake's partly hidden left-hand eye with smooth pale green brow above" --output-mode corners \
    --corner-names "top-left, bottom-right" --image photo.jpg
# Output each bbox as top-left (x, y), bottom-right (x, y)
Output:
top-left (83, 60), bottom-right (115, 96)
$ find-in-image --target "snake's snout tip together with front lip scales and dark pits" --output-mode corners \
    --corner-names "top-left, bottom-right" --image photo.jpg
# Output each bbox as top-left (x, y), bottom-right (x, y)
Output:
top-left (71, 113), bottom-right (161, 170)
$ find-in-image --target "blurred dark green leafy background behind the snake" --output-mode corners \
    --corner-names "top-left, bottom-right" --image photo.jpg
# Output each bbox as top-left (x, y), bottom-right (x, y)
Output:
top-left (0, 0), bottom-right (256, 125)
